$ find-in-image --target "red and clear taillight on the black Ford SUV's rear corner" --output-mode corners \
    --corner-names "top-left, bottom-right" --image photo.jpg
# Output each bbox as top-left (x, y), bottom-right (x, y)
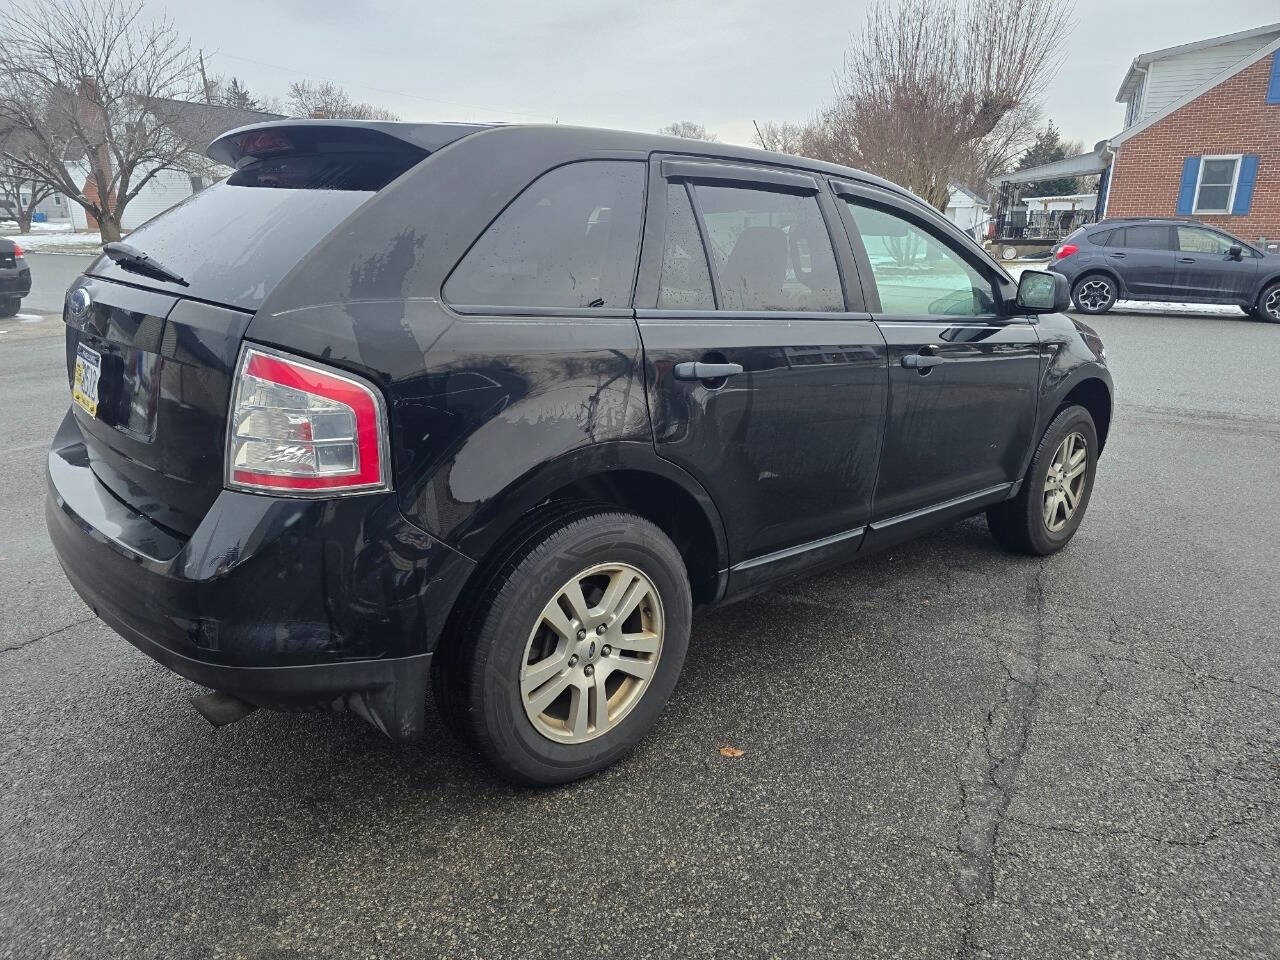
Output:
top-left (227, 347), bottom-right (388, 495)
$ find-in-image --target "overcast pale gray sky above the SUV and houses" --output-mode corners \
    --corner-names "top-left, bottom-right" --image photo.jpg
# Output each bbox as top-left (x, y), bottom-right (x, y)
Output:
top-left (183, 0), bottom-right (1280, 154)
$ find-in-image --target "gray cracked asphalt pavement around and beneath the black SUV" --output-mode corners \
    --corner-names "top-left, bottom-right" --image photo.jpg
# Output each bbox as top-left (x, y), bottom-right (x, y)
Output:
top-left (0, 315), bottom-right (1280, 960)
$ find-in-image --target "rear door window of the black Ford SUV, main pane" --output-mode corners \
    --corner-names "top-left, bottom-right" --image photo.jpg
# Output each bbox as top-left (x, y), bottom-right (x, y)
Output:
top-left (694, 184), bottom-right (845, 311)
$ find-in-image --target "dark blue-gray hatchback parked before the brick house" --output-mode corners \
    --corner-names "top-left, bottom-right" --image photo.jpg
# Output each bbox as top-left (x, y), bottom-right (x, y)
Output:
top-left (1050, 220), bottom-right (1280, 323)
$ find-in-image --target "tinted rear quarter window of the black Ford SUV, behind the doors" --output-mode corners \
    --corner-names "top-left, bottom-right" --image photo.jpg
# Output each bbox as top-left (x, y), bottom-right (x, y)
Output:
top-left (444, 160), bottom-right (645, 307)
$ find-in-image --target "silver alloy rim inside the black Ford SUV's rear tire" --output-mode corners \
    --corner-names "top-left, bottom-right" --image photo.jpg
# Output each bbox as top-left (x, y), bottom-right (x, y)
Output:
top-left (520, 563), bottom-right (663, 744)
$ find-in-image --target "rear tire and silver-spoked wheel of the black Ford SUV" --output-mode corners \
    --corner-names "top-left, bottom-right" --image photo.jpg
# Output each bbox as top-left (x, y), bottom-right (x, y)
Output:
top-left (433, 506), bottom-right (692, 786)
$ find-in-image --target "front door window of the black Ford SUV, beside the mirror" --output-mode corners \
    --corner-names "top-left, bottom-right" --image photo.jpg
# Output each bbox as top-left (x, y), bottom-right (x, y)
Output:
top-left (845, 200), bottom-right (997, 316)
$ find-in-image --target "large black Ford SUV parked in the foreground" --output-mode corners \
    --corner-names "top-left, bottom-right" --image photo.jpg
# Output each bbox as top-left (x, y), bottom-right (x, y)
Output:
top-left (47, 120), bottom-right (1111, 783)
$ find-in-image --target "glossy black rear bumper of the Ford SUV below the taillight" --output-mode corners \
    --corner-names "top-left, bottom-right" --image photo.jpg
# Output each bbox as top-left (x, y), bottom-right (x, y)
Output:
top-left (46, 415), bottom-right (472, 740)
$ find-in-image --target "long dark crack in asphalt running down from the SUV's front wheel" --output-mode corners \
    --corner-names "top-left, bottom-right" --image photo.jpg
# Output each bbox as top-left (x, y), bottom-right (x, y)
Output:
top-left (954, 559), bottom-right (1044, 957)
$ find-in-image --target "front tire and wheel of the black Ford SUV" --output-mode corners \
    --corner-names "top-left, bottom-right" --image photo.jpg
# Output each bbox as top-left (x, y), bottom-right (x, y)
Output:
top-left (987, 404), bottom-right (1098, 557)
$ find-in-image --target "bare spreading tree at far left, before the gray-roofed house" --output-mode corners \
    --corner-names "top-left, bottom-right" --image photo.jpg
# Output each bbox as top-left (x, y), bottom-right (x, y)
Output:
top-left (0, 0), bottom-right (217, 242)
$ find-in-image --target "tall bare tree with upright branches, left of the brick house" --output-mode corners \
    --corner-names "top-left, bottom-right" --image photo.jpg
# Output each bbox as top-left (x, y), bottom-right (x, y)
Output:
top-left (805, 0), bottom-right (1074, 209)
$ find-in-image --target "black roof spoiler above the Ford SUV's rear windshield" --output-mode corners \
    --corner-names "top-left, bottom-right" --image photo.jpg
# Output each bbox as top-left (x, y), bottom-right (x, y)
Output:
top-left (205, 120), bottom-right (489, 168)
